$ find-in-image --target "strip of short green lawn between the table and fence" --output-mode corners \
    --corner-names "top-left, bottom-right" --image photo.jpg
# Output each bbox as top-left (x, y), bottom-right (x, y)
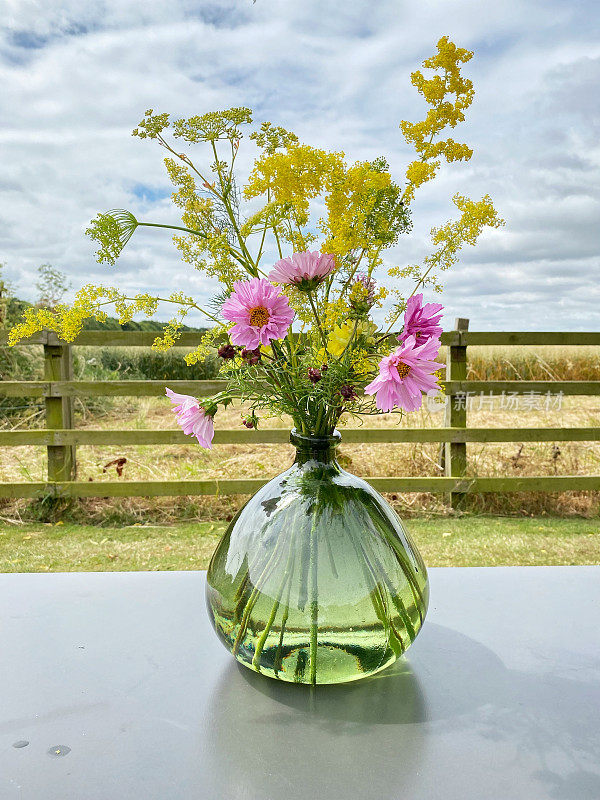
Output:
top-left (0, 516), bottom-right (600, 572)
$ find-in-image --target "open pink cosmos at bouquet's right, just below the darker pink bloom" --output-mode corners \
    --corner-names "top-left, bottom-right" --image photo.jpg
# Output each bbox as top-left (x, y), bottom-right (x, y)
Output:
top-left (365, 336), bottom-right (442, 411)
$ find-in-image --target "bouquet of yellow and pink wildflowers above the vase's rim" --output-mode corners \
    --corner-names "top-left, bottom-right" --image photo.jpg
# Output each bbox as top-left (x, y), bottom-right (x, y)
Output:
top-left (11, 37), bottom-right (503, 447)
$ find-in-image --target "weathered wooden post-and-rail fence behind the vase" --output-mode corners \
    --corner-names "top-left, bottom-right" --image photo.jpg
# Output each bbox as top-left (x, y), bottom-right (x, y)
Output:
top-left (0, 319), bottom-right (600, 506)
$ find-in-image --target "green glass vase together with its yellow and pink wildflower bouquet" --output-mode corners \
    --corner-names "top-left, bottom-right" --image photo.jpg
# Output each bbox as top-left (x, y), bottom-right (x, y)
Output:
top-left (11, 37), bottom-right (502, 685)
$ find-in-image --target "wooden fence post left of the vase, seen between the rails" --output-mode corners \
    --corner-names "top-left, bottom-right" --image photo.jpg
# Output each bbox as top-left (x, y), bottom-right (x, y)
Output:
top-left (44, 332), bottom-right (77, 483)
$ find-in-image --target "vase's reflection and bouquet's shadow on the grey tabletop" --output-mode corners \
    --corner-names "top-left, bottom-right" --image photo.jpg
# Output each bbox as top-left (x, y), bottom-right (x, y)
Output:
top-left (205, 623), bottom-right (600, 800)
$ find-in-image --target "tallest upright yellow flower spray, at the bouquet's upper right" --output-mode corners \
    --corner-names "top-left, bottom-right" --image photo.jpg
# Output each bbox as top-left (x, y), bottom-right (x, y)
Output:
top-left (400, 36), bottom-right (475, 203)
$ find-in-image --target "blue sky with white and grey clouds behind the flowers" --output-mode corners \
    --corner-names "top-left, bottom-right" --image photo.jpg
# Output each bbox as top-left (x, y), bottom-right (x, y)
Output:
top-left (0, 0), bottom-right (600, 330)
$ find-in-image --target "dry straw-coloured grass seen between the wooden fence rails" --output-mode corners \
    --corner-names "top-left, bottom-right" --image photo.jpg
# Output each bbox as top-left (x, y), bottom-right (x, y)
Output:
top-left (0, 347), bottom-right (600, 525)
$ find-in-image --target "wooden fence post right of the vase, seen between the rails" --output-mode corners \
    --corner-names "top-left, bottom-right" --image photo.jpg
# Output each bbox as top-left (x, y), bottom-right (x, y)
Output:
top-left (444, 317), bottom-right (469, 509)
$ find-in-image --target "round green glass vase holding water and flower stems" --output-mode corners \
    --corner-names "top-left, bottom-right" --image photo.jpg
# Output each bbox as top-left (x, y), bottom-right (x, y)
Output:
top-left (207, 431), bottom-right (429, 685)
